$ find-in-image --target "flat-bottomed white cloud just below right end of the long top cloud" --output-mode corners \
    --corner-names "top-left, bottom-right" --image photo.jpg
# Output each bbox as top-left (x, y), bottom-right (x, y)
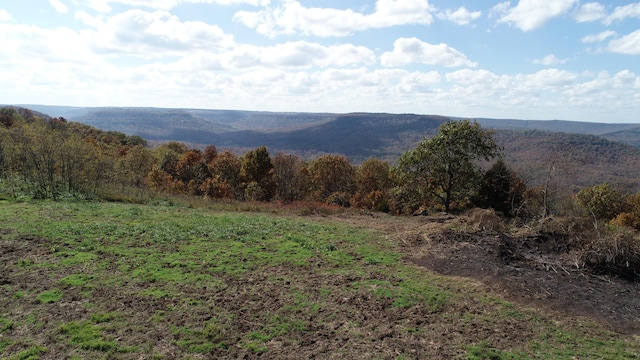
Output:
top-left (380, 38), bottom-right (477, 67)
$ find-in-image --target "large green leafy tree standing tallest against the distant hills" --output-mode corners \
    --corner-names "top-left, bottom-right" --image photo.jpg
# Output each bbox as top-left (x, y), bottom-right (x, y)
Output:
top-left (398, 120), bottom-right (500, 212)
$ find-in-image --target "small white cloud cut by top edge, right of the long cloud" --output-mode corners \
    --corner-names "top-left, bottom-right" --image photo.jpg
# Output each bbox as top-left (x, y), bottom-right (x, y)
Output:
top-left (498, 0), bottom-right (578, 32)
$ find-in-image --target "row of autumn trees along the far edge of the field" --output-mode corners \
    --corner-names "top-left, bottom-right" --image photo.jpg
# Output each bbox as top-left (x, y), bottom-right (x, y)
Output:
top-left (0, 107), bottom-right (640, 228)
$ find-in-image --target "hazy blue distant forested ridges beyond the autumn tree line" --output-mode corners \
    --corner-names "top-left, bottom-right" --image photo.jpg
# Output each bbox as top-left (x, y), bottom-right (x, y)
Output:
top-left (8, 105), bottom-right (640, 189)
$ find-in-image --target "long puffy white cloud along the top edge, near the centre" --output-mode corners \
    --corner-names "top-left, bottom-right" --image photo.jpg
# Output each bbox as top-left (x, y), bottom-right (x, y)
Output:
top-left (234, 0), bottom-right (434, 37)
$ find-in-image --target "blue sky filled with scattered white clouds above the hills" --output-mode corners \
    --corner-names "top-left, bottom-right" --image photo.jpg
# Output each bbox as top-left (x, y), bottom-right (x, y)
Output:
top-left (0, 0), bottom-right (640, 123)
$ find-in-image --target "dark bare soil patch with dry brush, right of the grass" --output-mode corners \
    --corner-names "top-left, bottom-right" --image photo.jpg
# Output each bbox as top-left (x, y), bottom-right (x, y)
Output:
top-left (384, 216), bottom-right (640, 334)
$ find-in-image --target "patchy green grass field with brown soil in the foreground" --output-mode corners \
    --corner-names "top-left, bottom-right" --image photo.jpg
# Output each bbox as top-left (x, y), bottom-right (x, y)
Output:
top-left (0, 201), bottom-right (640, 359)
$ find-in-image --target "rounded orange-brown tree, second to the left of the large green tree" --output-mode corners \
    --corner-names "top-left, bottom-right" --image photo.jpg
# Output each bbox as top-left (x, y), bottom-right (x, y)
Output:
top-left (309, 155), bottom-right (355, 206)
